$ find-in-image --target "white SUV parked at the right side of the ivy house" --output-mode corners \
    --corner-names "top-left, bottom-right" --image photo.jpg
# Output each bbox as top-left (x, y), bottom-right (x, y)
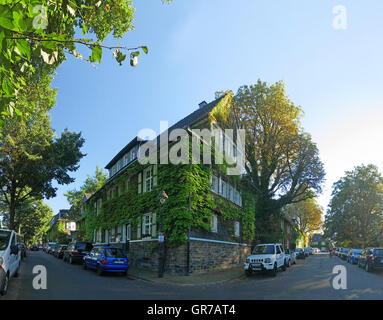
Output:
top-left (245, 243), bottom-right (286, 276)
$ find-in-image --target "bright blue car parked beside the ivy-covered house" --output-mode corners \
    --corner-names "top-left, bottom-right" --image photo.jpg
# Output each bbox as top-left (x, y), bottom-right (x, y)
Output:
top-left (83, 246), bottom-right (129, 276)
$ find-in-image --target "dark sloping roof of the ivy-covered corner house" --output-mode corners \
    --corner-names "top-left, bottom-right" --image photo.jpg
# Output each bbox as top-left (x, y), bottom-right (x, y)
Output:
top-left (105, 96), bottom-right (224, 169)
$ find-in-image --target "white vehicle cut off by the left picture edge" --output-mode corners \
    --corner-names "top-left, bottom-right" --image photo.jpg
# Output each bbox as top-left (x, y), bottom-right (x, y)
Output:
top-left (0, 229), bottom-right (21, 295)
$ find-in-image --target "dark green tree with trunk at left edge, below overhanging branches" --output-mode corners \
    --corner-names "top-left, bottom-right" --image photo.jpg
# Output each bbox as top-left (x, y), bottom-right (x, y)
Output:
top-left (0, 76), bottom-right (84, 229)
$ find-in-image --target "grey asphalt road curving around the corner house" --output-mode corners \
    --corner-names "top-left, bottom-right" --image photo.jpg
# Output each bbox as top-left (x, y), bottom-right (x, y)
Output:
top-left (0, 251), bottom-right (383, 300)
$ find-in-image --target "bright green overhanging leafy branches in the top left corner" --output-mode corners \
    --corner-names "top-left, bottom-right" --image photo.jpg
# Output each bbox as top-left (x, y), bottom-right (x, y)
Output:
top-left (0, 0), bottom-right (170, 128)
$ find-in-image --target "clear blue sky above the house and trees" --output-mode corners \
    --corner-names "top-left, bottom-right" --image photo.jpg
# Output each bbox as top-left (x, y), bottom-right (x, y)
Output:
top-left (46, 0), bottom-right (383, 218)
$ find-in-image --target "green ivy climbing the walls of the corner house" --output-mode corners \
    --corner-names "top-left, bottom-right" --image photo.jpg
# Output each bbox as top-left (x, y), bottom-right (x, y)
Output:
top-left (85, 142), bottom-right (255, 250)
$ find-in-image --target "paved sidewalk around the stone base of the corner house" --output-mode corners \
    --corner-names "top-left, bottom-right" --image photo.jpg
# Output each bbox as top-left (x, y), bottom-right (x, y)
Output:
top-left (128, 267), bottom-right (244, 286)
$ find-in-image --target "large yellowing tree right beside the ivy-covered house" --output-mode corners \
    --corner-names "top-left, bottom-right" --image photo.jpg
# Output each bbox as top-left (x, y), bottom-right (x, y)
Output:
top-left (233, 80), bottom-right (325, 241)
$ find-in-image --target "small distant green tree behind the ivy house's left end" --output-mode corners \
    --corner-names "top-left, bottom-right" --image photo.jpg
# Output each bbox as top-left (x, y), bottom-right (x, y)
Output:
top-left (65, 166), bottom-right (108, 218)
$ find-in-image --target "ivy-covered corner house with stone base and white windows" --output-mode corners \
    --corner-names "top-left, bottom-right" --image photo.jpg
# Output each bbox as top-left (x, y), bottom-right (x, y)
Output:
top-left (81, 92), bottom-right (255, 272)
